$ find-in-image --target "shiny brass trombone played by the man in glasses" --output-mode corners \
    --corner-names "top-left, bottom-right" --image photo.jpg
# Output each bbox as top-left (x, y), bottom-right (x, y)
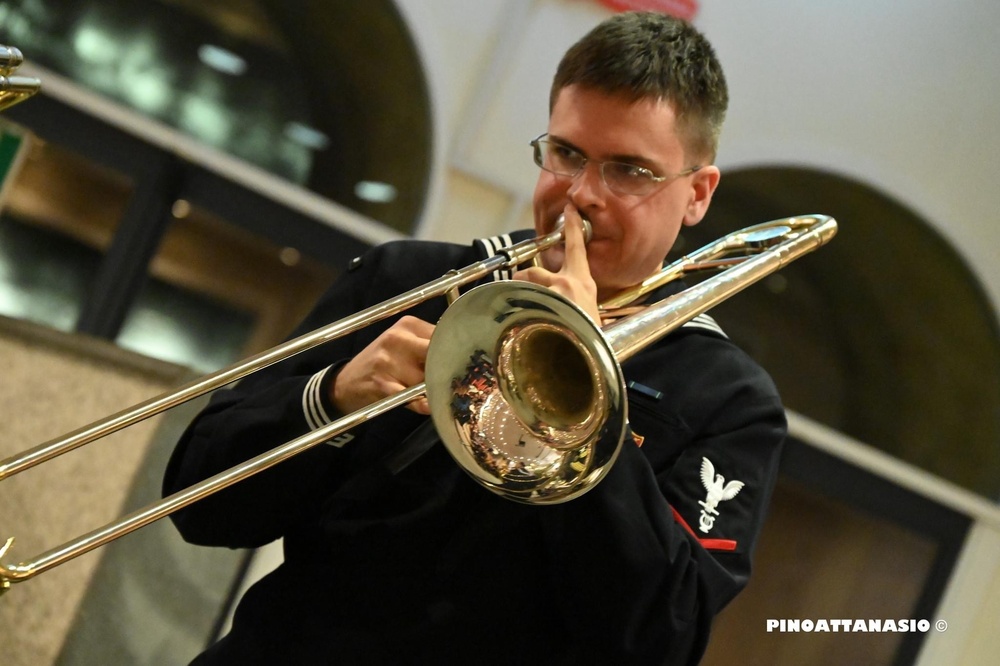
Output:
top-left (0, 215), bottom-right (837, 594)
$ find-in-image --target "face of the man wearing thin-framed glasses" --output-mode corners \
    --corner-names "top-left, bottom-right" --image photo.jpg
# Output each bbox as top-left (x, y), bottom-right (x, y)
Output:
top-left (533, 85), bottom-right (719, 299)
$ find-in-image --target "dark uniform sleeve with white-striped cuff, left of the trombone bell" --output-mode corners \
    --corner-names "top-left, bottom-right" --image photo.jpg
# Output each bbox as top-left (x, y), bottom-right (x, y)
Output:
top-left (163, 241), bottom-right (392, 548)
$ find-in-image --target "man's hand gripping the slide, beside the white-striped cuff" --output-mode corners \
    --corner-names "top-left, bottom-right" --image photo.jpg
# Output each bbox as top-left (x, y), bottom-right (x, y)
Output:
top-left (330, 315), bottom-right (434, 414)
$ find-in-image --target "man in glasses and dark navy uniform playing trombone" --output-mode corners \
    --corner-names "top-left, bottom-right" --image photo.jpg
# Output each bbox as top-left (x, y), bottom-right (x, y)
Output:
top-left (164, 13), bottom-right (785, 664)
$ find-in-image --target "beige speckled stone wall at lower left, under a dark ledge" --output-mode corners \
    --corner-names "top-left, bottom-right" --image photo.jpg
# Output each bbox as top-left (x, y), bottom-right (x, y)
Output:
top-left (0, 318), bottom-right (187, 666)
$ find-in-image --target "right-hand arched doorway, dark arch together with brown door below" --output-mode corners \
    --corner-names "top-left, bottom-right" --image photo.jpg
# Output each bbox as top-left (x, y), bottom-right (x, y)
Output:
top-left (700, 167), bottom-right (1000, 664)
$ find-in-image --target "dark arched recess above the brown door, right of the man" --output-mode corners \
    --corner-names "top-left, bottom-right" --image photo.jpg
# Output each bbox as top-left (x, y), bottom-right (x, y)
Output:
top-left (683, 167), bottom-right (1000, 499)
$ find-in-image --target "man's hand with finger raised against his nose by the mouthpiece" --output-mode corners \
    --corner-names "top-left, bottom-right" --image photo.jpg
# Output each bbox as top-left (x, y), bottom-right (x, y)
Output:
top-left (513, 204), bottom-right (601, 324)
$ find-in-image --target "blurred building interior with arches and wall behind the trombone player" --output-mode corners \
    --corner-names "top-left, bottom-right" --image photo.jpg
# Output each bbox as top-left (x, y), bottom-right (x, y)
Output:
top-left (0, 0), bottom-right (1000, 665)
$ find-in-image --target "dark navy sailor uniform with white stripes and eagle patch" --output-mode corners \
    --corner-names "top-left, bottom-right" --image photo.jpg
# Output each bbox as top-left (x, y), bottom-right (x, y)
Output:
top-left (164, 234), bottom-right (785, 665)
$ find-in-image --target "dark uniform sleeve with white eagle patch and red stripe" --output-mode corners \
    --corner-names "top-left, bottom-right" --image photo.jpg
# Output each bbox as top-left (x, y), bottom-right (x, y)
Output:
top-left (546, 334), bottom-right (785, 663)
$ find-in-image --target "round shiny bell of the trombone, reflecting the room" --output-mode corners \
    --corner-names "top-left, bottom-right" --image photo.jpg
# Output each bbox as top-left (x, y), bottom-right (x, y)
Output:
top-left (426, 282), bottom-right (627, 504)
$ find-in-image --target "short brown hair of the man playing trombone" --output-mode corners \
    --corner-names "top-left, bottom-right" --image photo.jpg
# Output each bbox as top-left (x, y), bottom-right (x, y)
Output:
top-left (549, 12), bottom-right (729, 162)
